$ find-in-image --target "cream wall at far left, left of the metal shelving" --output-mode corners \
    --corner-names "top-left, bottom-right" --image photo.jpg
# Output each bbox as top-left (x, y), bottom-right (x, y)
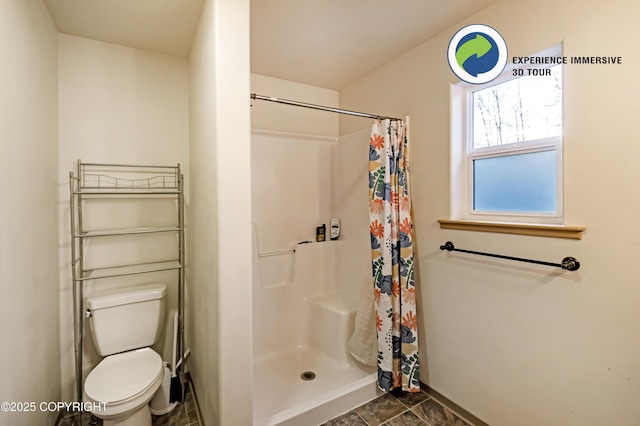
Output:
top-left (0, 0), bottom-right (60, 426)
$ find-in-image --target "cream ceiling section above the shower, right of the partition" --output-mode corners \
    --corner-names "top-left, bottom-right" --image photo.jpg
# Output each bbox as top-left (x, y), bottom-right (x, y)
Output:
top-left (251, 0), bottom-right (495, 89)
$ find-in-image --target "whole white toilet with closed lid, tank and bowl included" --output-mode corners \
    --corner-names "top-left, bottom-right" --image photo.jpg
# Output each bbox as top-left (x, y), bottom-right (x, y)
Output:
top-left (84, 284), bottom-right (167, 426)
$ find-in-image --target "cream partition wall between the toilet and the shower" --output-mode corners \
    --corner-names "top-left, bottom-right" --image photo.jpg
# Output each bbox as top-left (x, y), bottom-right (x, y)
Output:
top-left (188, 0), bottom-right (252, 426)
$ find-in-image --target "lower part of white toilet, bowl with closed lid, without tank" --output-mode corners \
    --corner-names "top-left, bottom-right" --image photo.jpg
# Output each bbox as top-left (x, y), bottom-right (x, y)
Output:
top-left (84, 348), bottom-right (164, 426)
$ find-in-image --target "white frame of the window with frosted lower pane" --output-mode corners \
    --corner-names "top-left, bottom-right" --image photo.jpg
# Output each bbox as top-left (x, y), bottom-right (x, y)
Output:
top-left (450, 45), bottom-right (564, 225)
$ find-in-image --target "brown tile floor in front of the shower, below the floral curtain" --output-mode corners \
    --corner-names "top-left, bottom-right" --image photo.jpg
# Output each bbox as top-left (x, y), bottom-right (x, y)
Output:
top-left (321, 391), bottom-right (474, 426)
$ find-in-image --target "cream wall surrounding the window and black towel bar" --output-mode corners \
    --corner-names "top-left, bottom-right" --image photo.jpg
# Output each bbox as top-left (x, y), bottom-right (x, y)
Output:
top-left (340, 0), bottom-right (640, 426)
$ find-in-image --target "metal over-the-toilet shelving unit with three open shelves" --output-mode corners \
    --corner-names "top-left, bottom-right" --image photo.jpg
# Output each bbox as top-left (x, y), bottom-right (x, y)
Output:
top-left (69, 160), bottom-right (185, 402)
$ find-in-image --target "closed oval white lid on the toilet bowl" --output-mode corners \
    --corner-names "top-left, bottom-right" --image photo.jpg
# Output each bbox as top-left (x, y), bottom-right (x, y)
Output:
top-left (84, 348), bottom-right (162, 404)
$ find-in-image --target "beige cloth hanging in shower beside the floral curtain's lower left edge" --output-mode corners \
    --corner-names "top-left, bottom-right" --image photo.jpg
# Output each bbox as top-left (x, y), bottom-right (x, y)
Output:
top-left (347, 271), bottom-right (378, 365)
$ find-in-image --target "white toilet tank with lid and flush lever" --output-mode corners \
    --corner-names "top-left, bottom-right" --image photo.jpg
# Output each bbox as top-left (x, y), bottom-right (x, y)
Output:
top-left (86, 284), bottom-right (167, 356)
